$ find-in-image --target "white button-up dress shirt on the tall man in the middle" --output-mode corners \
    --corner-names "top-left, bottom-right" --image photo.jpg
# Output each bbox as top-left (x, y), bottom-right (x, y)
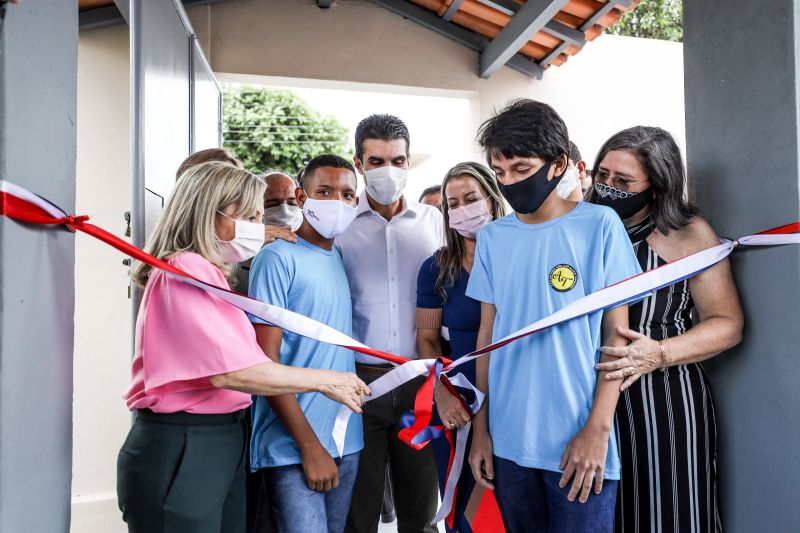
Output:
top-left (336, 191), bottom-right (444, 365)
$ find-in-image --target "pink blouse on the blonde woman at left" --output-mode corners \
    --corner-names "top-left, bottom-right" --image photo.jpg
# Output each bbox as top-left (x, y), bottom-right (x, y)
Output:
top-left (124, 252), bottom-right (271, 414)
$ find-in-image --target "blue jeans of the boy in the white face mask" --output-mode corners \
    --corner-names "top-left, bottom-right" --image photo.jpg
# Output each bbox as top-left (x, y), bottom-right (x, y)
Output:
top-left (263, 453), bottom-right (359, 533)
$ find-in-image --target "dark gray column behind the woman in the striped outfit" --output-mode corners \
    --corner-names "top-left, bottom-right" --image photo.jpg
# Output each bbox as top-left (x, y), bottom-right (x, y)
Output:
top-left (683, 0), bottom-right (800, 532)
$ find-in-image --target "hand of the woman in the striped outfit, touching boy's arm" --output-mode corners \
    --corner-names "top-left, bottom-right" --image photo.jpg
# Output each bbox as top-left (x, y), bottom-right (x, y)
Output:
top-left (595, 327), bottom-right (663, 391)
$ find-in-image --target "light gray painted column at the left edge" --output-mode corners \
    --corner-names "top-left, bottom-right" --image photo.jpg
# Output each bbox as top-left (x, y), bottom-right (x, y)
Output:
top-left (0, 0), bottom-right (77, 533)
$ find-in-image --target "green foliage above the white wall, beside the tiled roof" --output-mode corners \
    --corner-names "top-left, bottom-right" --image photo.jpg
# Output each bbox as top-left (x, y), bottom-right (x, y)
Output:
top-left (608, 0), bottom-right (683, 42)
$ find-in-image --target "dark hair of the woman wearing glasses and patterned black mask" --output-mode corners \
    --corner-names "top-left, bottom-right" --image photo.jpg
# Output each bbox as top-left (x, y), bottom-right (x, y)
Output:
top-left (586, 126), bottom-right (699, 235)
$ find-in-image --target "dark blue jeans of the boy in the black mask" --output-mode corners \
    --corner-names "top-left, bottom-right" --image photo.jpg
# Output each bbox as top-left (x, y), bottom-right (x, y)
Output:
top-left (494, 455), bottom-right (619, 533)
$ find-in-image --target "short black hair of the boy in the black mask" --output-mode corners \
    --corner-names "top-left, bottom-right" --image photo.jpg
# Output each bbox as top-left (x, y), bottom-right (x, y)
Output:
top-left (478, 98), bottom-right (569, 162)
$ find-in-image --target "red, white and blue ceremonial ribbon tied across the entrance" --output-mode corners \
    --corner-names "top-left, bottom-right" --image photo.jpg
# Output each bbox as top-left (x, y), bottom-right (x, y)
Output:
top-left (0, 180), bottom-right (800, 523)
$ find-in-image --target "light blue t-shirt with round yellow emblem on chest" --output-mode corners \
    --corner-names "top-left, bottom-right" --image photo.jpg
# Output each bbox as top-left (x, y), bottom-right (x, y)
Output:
top-left (467, 202), bottom-right (640, 479)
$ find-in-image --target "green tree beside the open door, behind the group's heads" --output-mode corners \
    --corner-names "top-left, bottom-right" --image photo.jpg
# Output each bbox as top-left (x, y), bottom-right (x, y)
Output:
top-left (223, 86), bottom-right (353, 175)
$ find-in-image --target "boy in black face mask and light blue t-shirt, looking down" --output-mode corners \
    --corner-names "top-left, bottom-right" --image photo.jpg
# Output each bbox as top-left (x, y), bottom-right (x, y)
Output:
top-left (467, 100), bottom-right (640, 533)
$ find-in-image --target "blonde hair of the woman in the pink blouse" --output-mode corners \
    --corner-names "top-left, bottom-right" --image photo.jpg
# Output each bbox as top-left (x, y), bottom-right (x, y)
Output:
top-left (131, 161), bottom-right (266, 286)
